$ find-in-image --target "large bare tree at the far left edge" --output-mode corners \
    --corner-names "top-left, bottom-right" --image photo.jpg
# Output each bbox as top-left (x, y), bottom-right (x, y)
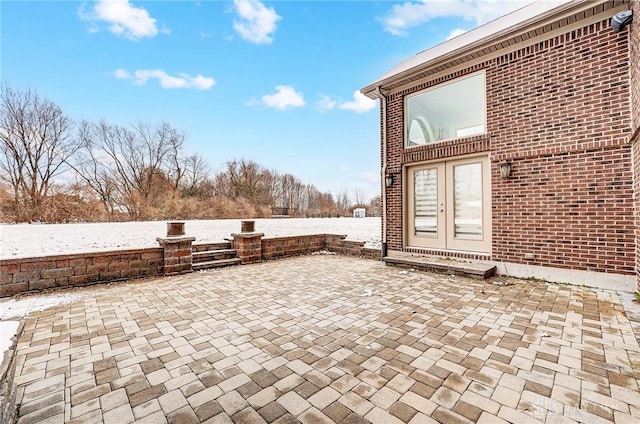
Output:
top-left (0, 85), bottom-right (78, 222)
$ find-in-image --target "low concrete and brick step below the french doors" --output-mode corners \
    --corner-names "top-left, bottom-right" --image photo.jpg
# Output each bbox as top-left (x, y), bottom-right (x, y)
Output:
top-left (382, 252), bottom-right (496, 279)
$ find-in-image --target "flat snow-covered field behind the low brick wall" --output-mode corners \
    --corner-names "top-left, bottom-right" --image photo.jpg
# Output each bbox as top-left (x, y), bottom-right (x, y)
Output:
top-left (0, 218), bottom-right (381, 259)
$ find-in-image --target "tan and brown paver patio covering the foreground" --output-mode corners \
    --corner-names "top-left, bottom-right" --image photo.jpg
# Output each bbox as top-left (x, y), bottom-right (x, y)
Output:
top-left (5, 255), bottom-right (640, 424)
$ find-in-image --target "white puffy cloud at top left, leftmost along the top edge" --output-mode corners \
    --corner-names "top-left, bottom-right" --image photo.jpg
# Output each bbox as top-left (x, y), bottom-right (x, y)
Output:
top-left (78, 0), bottom-right (161, 40)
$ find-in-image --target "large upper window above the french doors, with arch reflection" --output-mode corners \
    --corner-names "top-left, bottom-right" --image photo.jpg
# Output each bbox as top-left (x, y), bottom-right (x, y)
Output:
top-left (405, 73), bottom-right (487, 147)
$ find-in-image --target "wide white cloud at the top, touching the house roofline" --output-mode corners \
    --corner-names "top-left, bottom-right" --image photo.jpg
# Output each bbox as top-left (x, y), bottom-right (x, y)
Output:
top-left (379, 0), bottom-right (536, 35)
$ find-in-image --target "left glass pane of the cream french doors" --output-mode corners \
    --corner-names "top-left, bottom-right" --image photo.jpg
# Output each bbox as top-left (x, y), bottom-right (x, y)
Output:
top-left (413, 168), bottom-right (438, 238)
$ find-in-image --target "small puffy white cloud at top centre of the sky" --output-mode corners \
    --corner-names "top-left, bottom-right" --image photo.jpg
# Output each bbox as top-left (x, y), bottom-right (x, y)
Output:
top-left (233, 0), bottom-right (282, 44)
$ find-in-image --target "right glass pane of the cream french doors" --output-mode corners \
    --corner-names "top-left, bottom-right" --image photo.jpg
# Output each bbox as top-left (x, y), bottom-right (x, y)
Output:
top-left (453, 162), bottom-right (483, 240)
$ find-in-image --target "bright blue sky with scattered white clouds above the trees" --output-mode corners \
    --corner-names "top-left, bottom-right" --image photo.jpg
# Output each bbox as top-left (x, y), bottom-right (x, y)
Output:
top-left (0, 0), bottom-right (530, 202)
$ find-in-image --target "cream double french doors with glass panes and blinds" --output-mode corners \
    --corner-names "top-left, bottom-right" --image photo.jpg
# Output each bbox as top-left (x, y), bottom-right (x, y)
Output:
top-left (407, 156), bottom-right (491, 253)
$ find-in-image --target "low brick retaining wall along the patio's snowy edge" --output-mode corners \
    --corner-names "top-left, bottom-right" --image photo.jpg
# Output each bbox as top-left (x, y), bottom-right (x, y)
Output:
top-left (0, 234), bottom-right (381, 297)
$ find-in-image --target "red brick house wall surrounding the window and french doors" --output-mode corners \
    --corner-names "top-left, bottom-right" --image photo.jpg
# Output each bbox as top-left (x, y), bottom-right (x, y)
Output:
top-left (387, 15), bottom-right (638, 274)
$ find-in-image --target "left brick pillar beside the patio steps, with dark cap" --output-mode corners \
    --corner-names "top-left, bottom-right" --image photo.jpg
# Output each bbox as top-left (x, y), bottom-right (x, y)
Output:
top-left (156, 222), bottom-right (196, 275)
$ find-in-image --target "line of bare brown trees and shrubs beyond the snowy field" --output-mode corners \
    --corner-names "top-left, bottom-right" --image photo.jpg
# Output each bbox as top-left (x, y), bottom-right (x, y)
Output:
top-left (0, 84), bottom-right (380, 223)
